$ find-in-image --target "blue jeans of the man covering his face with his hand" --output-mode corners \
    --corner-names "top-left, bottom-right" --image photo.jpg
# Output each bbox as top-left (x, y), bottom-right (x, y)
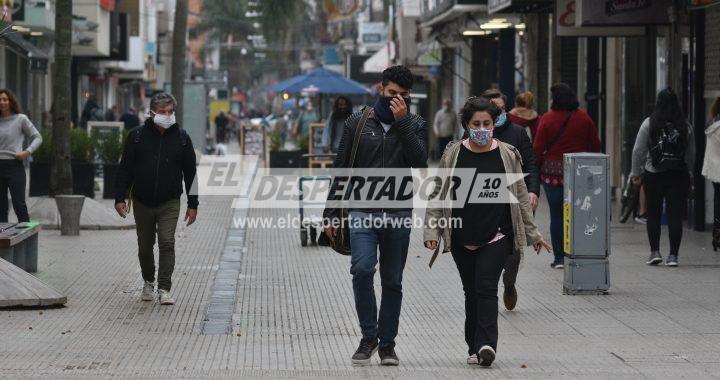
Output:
top-left (350, 215), bottom-right (410, 347)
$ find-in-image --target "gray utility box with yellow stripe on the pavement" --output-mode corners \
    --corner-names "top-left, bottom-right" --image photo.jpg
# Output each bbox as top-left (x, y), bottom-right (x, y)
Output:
top-left (563, 153), bottom-right (610, 294)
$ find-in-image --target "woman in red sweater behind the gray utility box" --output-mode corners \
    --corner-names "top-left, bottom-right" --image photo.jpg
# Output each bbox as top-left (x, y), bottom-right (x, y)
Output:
top-left (533, 83), bottom-right (600, 269)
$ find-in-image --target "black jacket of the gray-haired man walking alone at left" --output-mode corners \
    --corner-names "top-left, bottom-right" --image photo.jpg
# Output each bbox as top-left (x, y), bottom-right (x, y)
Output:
top-left (115, 119), bottom-right (198, 208)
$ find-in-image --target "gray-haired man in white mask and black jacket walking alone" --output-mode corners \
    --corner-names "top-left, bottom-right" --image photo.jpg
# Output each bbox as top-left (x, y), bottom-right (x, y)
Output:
top-left (115, 93), bottom-right (198, 305)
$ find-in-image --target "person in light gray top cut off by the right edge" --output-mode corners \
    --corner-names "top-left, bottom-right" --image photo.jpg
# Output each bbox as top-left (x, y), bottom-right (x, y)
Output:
top-left (702, 96), bottom-right (720, 251)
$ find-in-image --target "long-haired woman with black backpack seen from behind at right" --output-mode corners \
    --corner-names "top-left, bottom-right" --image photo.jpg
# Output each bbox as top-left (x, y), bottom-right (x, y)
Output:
top-left (630, 88), bottom-right (695, 267)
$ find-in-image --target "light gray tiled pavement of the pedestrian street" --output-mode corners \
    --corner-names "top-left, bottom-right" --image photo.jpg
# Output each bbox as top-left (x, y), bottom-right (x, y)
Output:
top-left (0, 159), bottom-right (720, 378)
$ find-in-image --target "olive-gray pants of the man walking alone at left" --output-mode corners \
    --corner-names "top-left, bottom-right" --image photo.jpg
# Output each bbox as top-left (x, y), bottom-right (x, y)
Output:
top-left (133, 199), bottom-right (180, 291)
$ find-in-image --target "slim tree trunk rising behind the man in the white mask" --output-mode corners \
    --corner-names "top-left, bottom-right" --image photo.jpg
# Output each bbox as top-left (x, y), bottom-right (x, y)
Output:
top-left (172, 0), bottom-right (188, 125)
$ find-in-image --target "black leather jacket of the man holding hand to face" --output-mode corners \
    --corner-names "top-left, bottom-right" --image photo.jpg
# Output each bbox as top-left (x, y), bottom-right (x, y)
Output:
top-left (323, 111), bottom-right (428, 218)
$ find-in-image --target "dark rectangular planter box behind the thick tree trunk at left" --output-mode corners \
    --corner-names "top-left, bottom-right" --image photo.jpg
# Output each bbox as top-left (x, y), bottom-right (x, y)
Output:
top-left (30, 162), bottom-right (95, 198)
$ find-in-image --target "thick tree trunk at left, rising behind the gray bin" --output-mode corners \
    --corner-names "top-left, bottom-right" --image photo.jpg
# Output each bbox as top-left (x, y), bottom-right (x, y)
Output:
top-left (50, 0), bottom-right (73, 195)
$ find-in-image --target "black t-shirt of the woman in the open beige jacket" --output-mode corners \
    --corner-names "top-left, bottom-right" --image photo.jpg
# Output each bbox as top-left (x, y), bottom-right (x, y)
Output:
top-left (452, 145), bottom-right (513, 246)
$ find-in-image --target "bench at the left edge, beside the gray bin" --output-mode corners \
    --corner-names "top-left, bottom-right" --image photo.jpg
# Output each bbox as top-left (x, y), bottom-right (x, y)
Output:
top-left (0, 222), bottom-right (40, 273)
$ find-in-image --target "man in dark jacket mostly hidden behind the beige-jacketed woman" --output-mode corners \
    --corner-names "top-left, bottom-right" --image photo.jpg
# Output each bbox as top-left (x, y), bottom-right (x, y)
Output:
top-left (481, 89), bottom-right (540, 310)
